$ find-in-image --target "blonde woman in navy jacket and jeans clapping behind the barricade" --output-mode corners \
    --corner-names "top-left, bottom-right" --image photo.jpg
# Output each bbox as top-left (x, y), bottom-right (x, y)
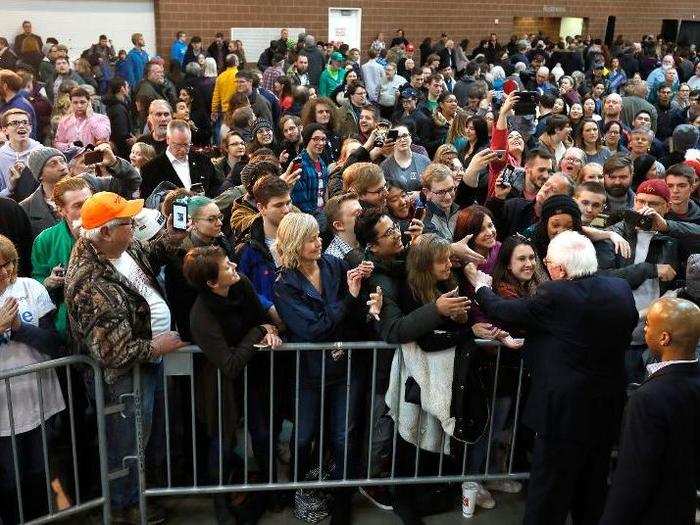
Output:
top-left (273, 213), bottom-right (381, 523)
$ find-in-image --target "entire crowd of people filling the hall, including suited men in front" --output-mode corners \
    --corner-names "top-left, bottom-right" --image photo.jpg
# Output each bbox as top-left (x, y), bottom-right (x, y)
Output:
top-left (0, 21), bottom-right (700, 525)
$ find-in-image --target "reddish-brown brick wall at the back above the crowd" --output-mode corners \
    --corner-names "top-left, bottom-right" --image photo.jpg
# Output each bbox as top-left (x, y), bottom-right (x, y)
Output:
top-left (154, 0), bottom-right (700, 61)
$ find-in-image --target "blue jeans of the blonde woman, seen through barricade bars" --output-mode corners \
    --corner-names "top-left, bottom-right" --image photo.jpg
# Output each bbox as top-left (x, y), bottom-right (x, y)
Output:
top-left (290, 368), bottom-right (360, 480)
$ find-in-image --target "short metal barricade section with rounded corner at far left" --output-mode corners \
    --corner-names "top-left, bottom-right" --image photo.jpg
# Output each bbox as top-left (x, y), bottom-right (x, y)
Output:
top-left (0, 355), bottom-right (111, 524)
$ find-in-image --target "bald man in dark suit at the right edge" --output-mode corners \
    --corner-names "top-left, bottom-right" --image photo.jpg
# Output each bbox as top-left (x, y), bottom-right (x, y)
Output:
top-left (600, 298), bottom-right (700, 525)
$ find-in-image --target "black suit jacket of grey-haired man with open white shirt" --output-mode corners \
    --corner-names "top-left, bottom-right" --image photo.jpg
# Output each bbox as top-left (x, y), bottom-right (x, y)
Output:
top-left (141, 153), bottom-right (222, 199)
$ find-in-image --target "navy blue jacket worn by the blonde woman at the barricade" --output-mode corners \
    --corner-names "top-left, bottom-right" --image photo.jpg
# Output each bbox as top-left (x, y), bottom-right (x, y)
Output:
top-left (272, 254), bottom-right (360, 385)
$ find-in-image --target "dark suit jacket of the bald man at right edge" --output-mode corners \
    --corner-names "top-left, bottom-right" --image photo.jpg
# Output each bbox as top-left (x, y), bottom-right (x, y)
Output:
top-left (600, 363), bottom-right (700, 525)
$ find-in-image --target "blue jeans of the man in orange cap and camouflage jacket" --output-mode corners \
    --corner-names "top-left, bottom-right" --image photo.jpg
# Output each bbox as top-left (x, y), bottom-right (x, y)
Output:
top-left (104, 362), bottom-right (165, 509)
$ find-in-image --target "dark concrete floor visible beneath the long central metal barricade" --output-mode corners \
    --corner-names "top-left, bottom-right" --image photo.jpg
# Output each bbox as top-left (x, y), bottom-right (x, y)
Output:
top-left (160, 493), bottom-right (525, 525)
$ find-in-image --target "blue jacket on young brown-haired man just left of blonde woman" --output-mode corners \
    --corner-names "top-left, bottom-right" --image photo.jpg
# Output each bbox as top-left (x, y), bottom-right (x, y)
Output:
top-left (238, 217), bottom-right (277, 311)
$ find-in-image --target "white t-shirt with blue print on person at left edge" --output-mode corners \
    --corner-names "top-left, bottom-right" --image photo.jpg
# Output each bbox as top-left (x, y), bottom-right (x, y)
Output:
top-left (0, 277), bottom-right (66, 437)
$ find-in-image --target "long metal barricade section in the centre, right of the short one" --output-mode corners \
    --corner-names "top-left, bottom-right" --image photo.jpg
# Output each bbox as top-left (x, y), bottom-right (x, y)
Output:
top-left (129, 341), bottom-right (529, 523)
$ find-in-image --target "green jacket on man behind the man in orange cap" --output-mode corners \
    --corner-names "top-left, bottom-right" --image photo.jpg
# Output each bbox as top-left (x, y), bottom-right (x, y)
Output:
top-left (32, 220), bottom-right (75, 335)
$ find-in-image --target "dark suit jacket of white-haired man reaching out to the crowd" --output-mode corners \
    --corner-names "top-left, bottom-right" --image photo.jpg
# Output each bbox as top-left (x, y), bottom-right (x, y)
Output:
top-left (476, 275), bottom-right (639, 443)
